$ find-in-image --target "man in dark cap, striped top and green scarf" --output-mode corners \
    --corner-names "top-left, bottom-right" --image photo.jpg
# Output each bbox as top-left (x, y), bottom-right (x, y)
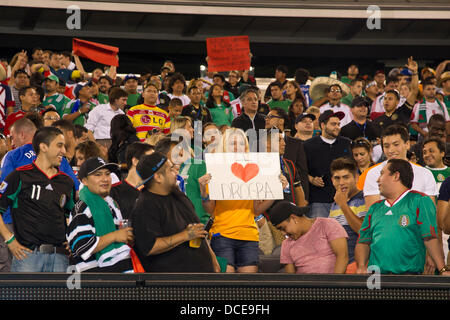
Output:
top-left (67, 158), bottom-right (134, 273)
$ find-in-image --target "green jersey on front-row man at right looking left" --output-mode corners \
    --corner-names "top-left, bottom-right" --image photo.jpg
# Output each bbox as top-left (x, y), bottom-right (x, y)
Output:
top-left (358, 190), bottom-right (437, 274)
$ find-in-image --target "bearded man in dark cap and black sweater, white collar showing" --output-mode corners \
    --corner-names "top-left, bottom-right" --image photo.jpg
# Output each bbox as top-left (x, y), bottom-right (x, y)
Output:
top-left (304, 110), bottom-right (351, 218)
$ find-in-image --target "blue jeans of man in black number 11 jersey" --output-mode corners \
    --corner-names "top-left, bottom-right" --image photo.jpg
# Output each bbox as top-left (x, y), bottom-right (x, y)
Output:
top-left (11, 251), bottom-right (69, 272)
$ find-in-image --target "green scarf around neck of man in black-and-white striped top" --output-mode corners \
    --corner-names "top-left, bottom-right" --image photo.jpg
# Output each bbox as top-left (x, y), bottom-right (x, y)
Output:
top-left (80, 186), bottom-right (128, 267)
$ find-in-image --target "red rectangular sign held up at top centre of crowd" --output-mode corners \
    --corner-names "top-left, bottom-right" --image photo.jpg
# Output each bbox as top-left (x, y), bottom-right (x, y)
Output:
top-left (206, 36), bottom-right (250, 72)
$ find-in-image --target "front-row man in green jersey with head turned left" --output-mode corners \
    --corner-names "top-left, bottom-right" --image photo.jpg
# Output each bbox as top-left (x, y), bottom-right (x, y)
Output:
top-left (355, 159), bottom-right (450, 275)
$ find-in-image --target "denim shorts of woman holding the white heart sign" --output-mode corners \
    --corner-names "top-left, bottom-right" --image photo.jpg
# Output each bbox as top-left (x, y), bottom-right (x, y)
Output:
top-left (211, 235), bottom-right (259, 268)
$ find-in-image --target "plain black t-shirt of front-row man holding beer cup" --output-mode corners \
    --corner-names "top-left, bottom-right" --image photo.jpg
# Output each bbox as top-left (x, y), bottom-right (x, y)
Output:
top-left (131, 190), bottom-right (214, 272)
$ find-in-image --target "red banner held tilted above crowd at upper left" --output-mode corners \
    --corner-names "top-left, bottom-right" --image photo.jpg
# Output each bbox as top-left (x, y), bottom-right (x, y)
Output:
top-left (72, 38), bottom-right (119, 67)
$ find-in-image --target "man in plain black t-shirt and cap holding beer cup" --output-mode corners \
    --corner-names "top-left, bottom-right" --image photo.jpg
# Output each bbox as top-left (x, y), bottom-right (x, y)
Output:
top-left (131, 152), bottom-right (220, 272)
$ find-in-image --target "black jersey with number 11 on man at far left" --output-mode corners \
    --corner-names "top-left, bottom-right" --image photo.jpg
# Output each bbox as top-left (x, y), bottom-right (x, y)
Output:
top-left (0, 162), bottom-right (75, 248)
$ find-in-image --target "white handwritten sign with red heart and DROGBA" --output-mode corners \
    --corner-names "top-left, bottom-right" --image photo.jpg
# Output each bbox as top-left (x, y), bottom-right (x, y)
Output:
top-left (205, 152), bottom-right (283, 200)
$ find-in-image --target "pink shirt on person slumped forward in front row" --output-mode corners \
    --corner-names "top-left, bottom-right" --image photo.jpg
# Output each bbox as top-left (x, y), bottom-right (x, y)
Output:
top-left (280, 218), bottom-right (348, 273)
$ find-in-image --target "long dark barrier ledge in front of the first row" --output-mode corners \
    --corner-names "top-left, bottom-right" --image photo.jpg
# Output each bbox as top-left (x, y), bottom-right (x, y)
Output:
top-left (0, 273), bottom-right (450, 303)
